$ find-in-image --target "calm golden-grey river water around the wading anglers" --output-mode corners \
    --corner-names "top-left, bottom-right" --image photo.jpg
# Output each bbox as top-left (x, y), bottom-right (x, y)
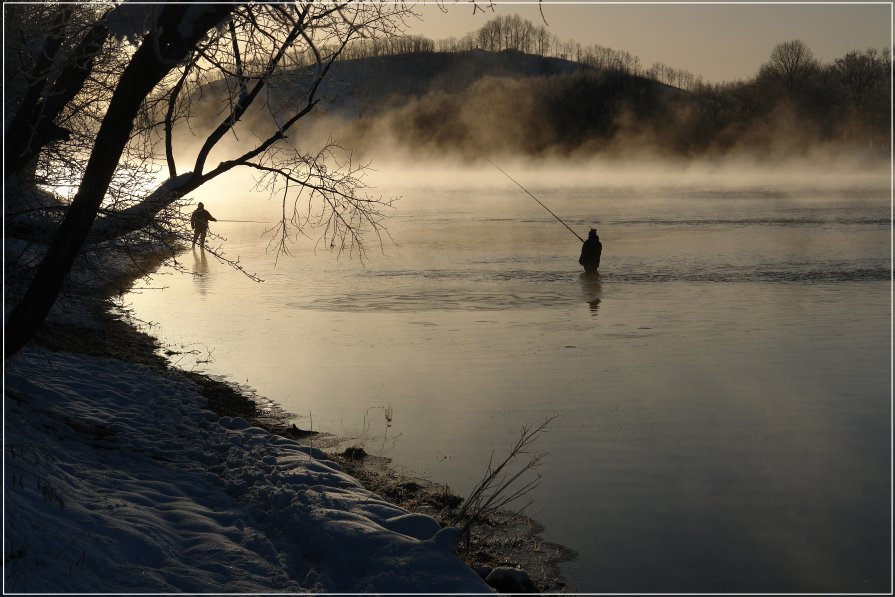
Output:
top-left (128, 164), bottom-right (892, 592)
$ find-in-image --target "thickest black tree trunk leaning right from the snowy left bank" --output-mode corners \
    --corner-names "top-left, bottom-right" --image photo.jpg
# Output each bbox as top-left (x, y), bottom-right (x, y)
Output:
top-left (4, 4), bottom-right (234, 357)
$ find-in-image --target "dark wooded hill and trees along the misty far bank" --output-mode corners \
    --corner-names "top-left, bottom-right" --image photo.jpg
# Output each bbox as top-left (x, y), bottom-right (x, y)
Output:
top-left (320, 15), bottom-right (891, 159)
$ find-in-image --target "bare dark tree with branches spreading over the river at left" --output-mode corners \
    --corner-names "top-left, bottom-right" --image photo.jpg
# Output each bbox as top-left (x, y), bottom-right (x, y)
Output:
top-left (4, 0), bottom-right (410, 356)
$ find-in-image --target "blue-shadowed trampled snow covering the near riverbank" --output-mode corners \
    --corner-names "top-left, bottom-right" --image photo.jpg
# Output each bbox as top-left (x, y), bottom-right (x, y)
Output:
top-left (4, 348), bottom-right (490, 593)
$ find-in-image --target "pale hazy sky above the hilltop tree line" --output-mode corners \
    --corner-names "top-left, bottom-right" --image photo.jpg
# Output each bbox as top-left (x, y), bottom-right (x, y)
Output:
top-left (411, 0), bottom-right (892, 82)
